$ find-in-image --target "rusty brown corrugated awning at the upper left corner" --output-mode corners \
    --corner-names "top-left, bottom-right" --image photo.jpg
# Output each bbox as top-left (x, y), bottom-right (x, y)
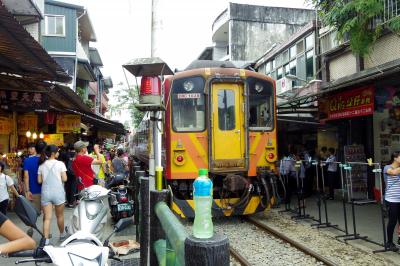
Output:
top-left (0, 2), bottom-right (71, 82)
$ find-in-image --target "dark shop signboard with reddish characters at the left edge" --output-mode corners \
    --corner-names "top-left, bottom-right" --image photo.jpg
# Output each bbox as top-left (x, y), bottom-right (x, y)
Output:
top-left (0, 90), bottom-right (49, 112)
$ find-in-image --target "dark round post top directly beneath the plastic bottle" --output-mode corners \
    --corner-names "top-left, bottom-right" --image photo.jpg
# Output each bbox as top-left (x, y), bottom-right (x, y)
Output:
top-left (185, 234), bottom-right (230, 266)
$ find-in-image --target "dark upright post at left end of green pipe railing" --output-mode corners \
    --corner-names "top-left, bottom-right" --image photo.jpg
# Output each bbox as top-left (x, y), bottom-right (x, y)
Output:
top-left (149, 189), bottom-right (169, 265)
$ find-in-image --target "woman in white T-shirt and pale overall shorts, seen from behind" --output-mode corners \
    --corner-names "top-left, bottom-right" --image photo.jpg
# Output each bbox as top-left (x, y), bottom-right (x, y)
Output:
top-left (38, 145), bottom-right (67, 243)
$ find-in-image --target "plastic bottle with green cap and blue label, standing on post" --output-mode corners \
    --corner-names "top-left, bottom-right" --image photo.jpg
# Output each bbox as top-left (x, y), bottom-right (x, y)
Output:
top-left (193, 169), bottom-right (214, 238)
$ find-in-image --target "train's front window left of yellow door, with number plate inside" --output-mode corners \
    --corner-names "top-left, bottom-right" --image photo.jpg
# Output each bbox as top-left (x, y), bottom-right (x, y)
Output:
top-left (172, 77), bottom-right (206, 132)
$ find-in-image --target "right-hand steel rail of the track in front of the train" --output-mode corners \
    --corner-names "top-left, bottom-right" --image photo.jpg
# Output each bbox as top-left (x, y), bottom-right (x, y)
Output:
top-left (247, 217), bottom-right (338, 266)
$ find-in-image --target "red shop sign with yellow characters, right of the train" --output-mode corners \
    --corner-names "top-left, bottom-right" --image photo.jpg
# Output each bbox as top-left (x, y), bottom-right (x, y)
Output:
top-left (319, 87), bottom-right (374, 120)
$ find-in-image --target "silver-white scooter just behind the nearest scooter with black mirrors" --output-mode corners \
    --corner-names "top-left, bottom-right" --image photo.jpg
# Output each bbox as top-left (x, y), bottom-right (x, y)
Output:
top-left (65, 185), bottom-right (110, 239)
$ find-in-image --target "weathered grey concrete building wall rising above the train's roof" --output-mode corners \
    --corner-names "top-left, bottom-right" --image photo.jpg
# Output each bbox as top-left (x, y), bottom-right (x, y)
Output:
top-left (229, 3), bottom-right (315, 61)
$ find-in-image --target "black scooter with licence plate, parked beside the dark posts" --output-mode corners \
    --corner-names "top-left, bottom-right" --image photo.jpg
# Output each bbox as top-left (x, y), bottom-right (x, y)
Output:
top-left (106, 175), bottom-right (133, 222)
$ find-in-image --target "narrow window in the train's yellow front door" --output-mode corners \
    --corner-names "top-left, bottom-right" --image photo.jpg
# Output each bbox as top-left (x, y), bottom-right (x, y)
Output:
top-left (218, 90), bottom-right (236, 131)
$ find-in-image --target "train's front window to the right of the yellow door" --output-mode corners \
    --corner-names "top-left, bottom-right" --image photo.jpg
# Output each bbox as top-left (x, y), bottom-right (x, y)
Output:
top-left (247, 77), bottom-right (274, 131)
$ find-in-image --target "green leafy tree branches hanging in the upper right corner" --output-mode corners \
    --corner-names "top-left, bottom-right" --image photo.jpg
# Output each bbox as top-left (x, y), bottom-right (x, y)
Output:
top-left (311, 0), bottom-right (400, 56)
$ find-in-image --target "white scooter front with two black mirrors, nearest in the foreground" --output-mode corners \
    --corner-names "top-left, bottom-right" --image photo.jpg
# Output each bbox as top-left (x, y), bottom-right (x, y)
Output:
top-left (8, 196), bottom-right (132, 266)
